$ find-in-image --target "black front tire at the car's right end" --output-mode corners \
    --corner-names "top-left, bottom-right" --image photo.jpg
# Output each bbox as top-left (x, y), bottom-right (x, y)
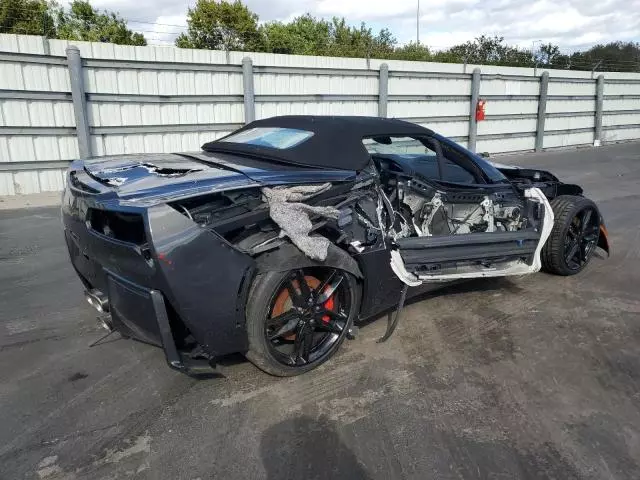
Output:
top-left (541, 195), bottom-right (600, 276)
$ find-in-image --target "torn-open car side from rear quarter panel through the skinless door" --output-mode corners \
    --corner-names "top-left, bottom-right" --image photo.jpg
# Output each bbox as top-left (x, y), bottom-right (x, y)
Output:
top-left (171, 156), bottom-right (553, 286)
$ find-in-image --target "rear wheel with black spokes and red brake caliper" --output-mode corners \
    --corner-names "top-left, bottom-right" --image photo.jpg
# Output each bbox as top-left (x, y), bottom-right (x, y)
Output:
top-left (246, 267), bottom-right (359, 377)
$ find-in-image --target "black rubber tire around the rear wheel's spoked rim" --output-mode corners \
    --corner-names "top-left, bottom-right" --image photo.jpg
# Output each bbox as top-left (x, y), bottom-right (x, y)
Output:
top-left (245, 268), bottom-right (360, 377)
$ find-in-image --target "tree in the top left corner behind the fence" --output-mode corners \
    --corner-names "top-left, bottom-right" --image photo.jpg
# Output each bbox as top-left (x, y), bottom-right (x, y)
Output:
top-left (0, 0), bottom-right (57, 37)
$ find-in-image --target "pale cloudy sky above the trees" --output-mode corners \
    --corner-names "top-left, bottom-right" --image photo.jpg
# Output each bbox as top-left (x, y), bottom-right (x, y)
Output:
top-left (91, 0), bottom-right (640, 51)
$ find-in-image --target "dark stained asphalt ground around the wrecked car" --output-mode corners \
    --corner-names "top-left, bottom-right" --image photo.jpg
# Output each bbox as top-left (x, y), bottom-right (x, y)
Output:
top-left (0, 143), bottom-right (640, 480)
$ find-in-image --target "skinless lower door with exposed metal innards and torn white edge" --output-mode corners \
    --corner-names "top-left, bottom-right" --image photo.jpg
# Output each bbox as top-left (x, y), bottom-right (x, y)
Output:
top-left (338, 164), bottom-right (553, 286)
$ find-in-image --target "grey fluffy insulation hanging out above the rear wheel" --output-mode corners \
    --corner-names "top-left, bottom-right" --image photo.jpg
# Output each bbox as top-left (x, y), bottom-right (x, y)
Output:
top-left (262, 183), bottom-right (339, 261)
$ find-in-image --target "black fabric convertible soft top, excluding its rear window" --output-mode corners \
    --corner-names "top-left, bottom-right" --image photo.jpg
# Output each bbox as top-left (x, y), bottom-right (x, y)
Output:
top-left (202, 115), bottom-right (433, 170)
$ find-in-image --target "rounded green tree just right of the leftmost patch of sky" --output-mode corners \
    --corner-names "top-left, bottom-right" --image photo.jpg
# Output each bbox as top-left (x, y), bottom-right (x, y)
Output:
top-left (176, 0), bottom-right (264, 51)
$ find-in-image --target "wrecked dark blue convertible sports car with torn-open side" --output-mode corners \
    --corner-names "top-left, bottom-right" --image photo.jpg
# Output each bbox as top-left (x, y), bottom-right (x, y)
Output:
top-left (62, 116), bottom-right (609, 376)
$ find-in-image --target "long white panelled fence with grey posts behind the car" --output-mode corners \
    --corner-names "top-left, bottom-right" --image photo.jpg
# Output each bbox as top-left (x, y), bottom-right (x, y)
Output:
top-left (0, 34), bottom-right (640, 195)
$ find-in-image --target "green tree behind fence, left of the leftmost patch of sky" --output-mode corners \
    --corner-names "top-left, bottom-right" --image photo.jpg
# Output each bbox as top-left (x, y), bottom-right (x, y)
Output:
top-left (57, 0), bottom-right (147, 45)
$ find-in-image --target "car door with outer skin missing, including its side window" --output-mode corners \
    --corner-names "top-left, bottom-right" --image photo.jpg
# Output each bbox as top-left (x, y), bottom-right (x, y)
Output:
top-left (368, 137), bottom-right (553, 282)
